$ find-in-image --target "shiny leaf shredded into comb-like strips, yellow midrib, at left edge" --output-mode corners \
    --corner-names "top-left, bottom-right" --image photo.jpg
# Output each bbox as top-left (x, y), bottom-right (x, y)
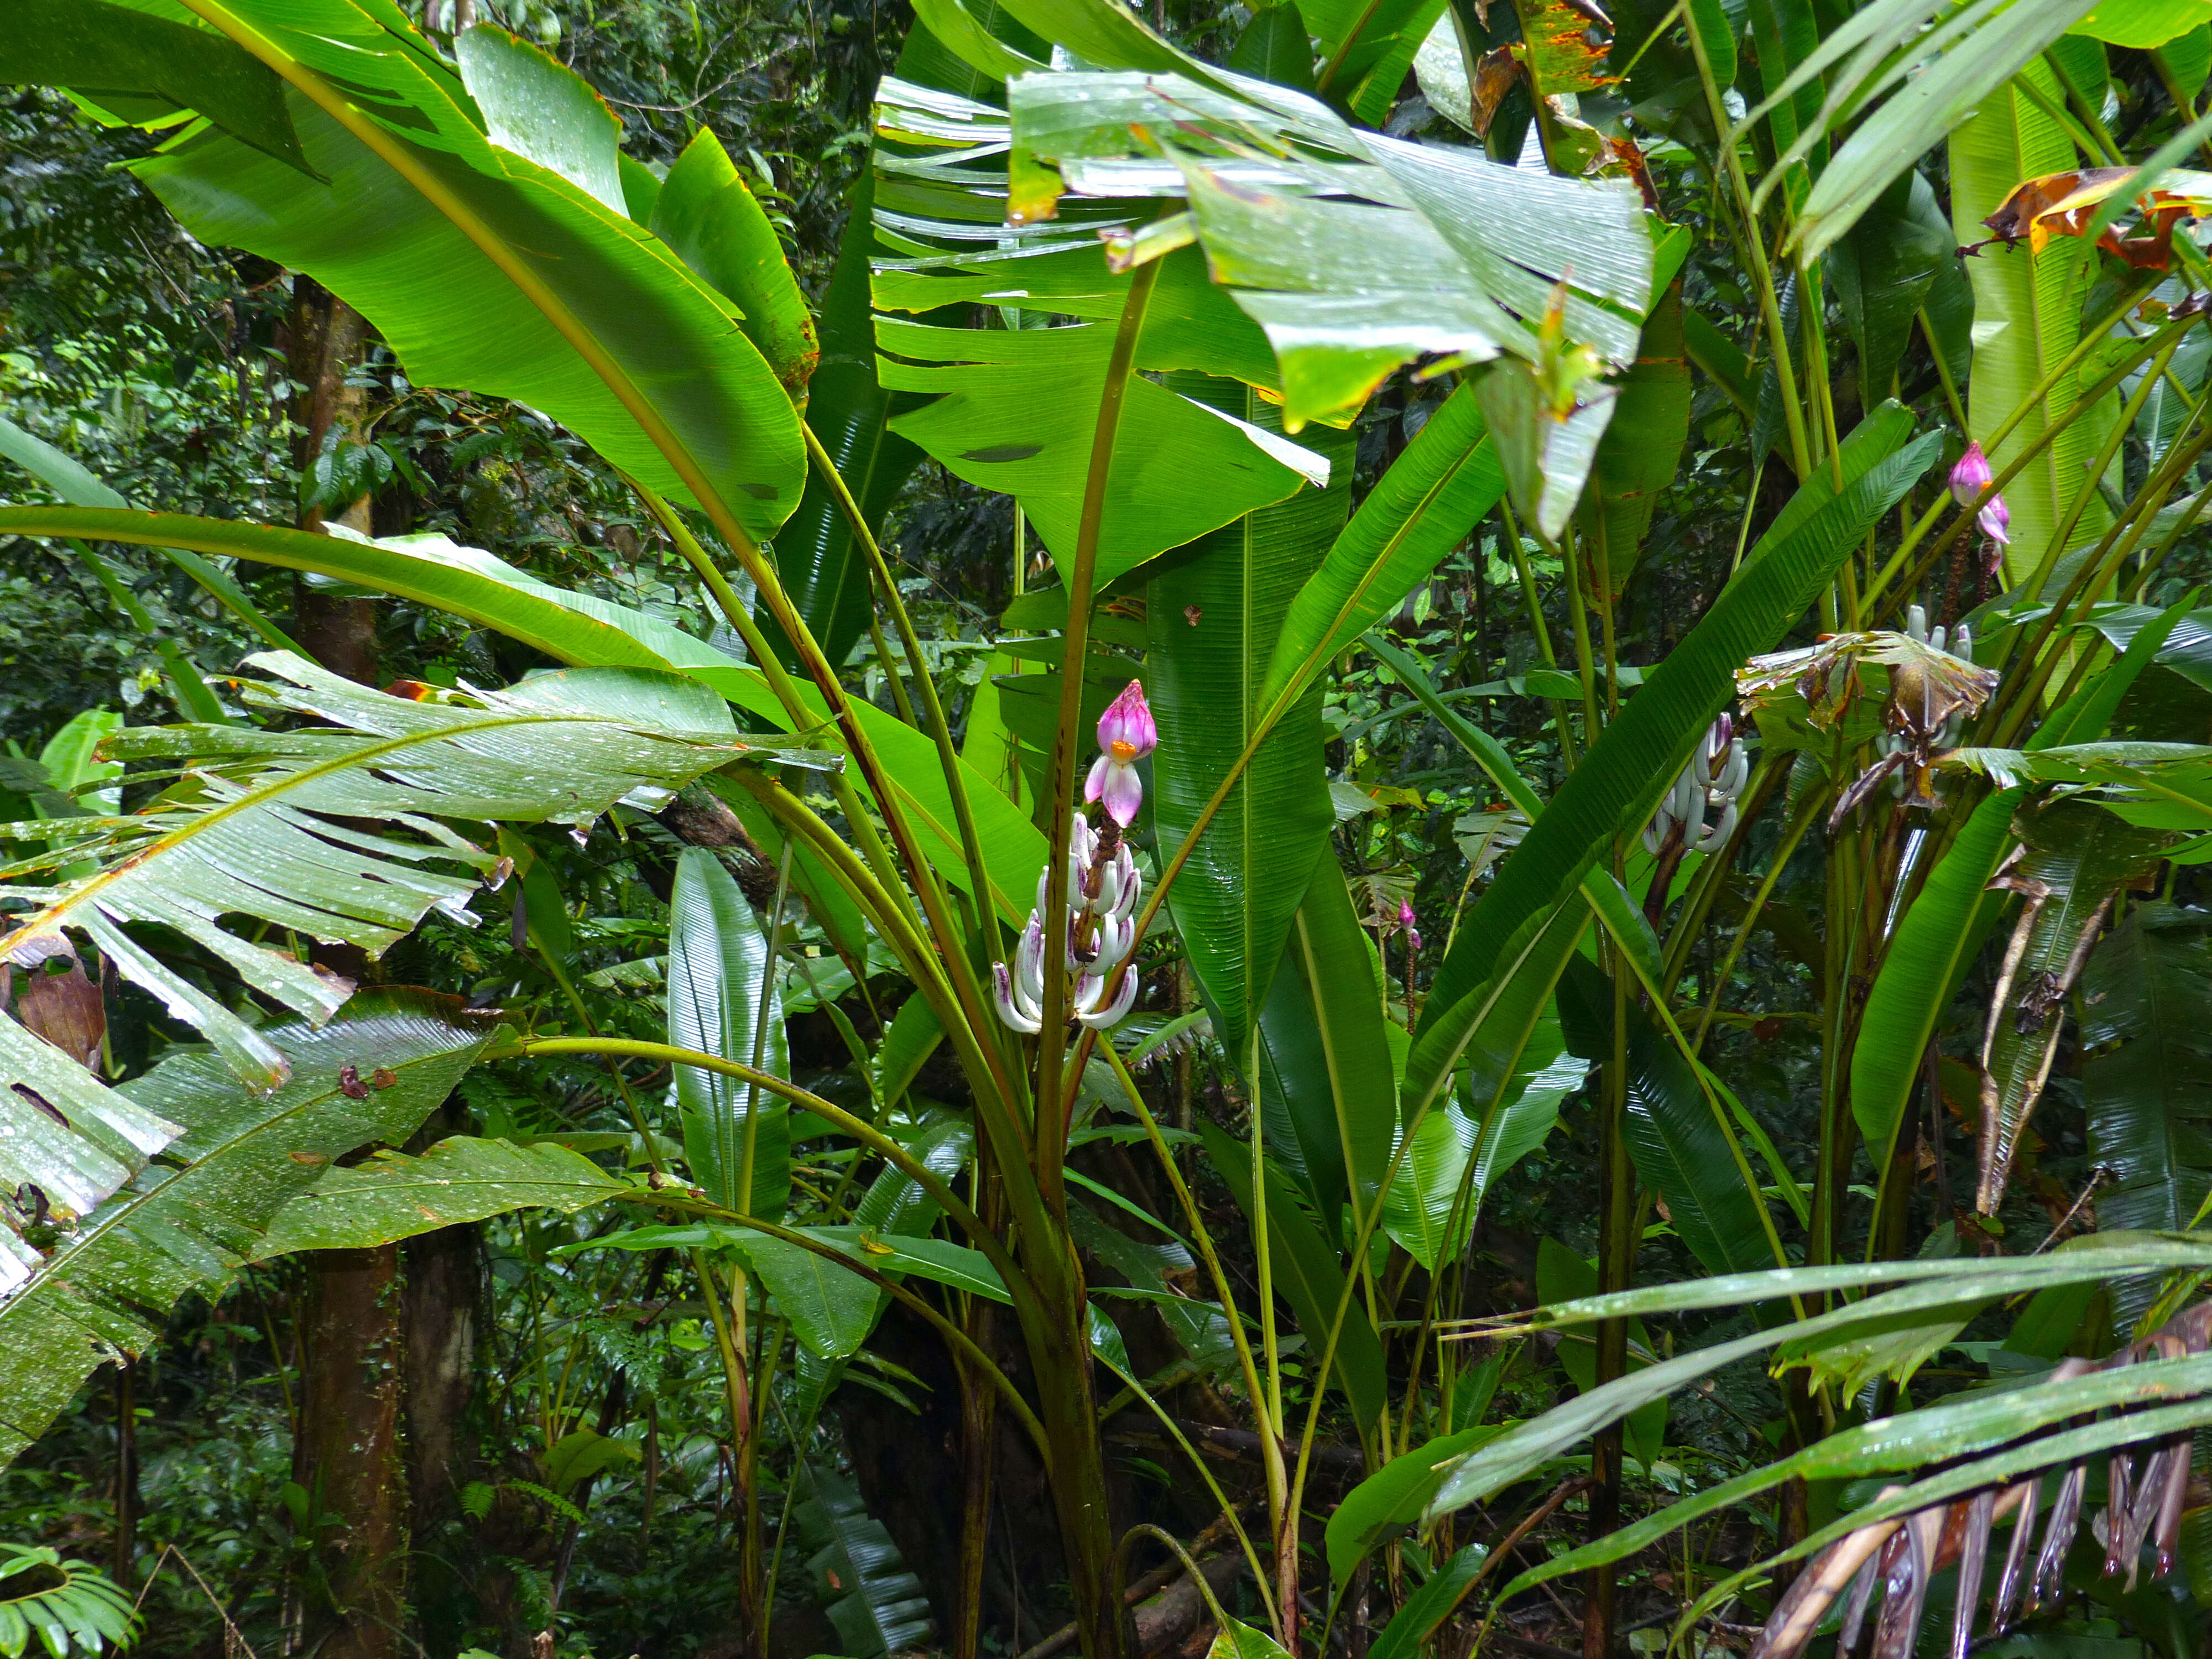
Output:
top-left (0, 653), bottom-right (765, 1088)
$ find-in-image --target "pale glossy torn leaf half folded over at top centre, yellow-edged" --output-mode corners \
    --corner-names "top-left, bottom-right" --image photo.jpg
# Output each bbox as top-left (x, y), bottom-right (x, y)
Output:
top-left (1009, 73), bottom-right (1652, 429)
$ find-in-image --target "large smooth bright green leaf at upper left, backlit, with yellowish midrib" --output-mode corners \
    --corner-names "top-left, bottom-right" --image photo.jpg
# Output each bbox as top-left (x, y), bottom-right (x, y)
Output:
top-left (91, 0), bottom-right (805, 540)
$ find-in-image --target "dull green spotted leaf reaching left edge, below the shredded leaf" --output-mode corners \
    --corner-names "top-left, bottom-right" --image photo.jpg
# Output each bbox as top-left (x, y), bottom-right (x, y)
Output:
top-left (0, 991), bottom-right (495, 1464)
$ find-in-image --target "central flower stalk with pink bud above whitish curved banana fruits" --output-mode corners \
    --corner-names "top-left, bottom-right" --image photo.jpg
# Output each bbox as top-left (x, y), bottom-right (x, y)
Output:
top-left (993, 679), bottom-right (1159, 1033)
